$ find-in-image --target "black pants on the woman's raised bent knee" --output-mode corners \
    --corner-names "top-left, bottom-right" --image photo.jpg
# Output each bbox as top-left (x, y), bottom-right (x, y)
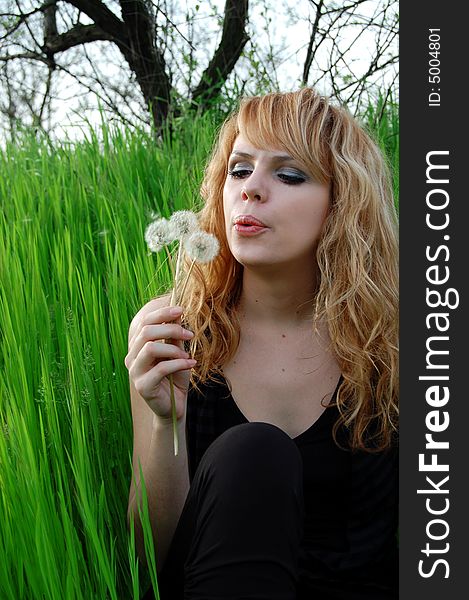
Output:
top-left (150, 423), bottom-right (304, 600)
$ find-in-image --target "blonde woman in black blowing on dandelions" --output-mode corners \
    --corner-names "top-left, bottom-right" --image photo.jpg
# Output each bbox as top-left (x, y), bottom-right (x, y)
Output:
top-left (125, 89), bottom-right (398, 600)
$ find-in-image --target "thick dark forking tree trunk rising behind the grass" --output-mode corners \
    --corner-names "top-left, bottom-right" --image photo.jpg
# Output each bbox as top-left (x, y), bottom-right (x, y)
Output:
top-left (9, 0), bottom-right (249, 131)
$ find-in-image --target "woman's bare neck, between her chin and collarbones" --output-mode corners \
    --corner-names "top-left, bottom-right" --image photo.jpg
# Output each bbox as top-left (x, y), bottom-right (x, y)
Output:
top-left (239, 267), bottom-right (316, 327)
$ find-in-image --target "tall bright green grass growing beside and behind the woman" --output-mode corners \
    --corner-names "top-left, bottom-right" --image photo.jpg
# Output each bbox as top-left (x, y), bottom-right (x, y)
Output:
top-left (0, 101), bottom-right (397, 600)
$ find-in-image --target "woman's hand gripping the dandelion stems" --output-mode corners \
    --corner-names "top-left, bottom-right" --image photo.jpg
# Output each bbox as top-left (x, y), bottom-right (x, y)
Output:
top-left (124, 306), bottom-right (197, 422)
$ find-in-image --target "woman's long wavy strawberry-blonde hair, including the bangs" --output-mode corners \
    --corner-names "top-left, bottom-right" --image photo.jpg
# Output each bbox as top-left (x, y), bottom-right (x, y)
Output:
top-left (172, 88), bottom-right (398, 452)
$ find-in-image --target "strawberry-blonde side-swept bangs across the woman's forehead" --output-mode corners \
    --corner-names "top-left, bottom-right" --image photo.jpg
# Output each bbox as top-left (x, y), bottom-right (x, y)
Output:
top-left (236, 90), bottom-right (331, 184)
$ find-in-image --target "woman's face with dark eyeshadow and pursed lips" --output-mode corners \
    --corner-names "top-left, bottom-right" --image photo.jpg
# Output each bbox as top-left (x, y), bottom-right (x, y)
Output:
top-left (223, 136), bottom-right (330, 267)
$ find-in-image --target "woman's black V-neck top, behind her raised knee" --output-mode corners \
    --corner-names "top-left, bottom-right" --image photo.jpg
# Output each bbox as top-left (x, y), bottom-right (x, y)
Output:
top-left (186, 376), bottom-right (398, 600)
